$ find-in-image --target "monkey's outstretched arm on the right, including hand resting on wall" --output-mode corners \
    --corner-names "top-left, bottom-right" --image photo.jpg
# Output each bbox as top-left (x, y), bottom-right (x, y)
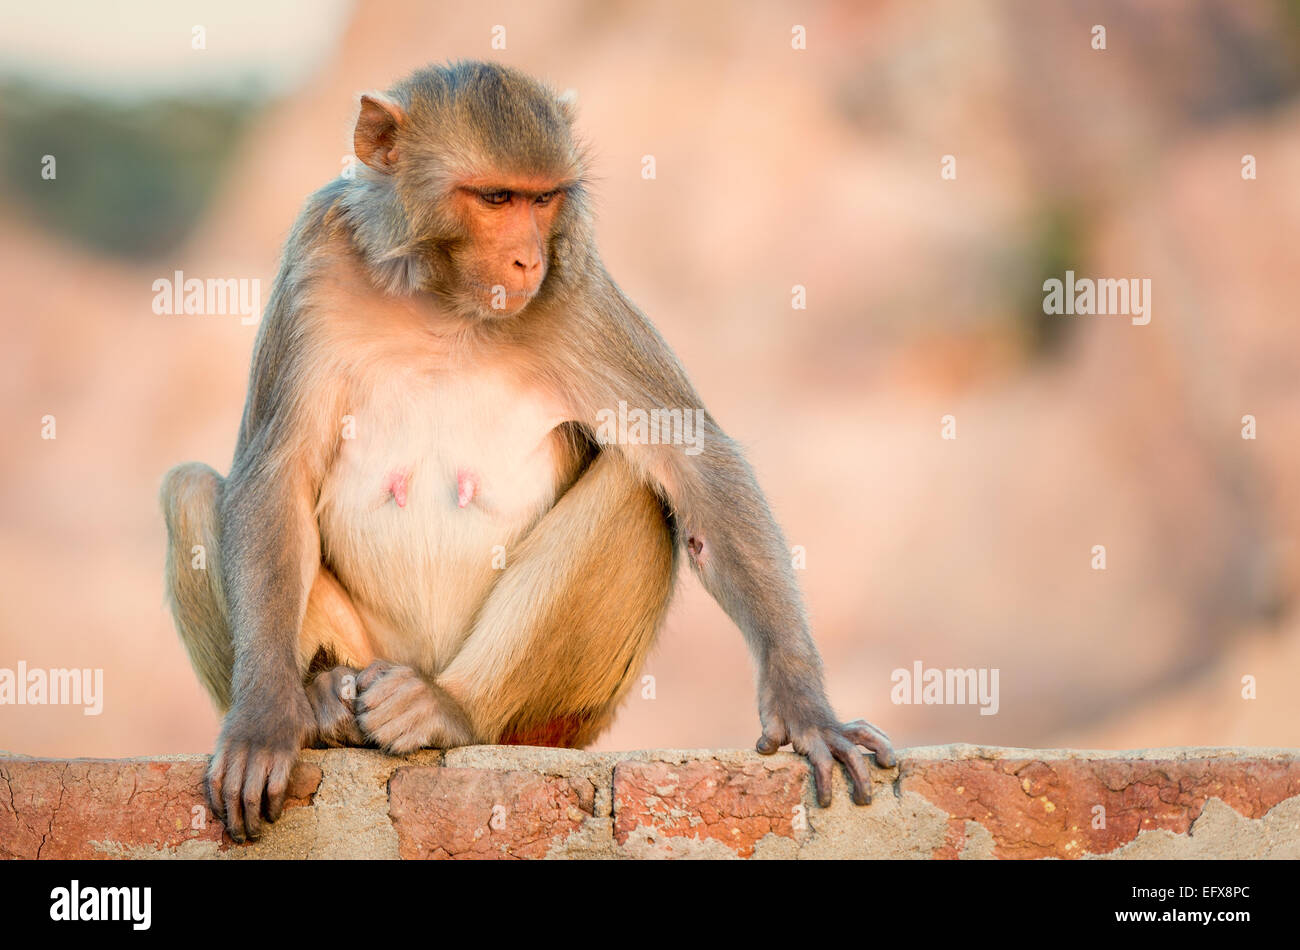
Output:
top-left (569, 290), bottom-right (894, 804)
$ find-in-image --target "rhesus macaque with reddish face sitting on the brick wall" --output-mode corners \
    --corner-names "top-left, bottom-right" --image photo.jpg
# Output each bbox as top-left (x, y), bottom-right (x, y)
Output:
top-left (161, 62), bottom-right (894, 841)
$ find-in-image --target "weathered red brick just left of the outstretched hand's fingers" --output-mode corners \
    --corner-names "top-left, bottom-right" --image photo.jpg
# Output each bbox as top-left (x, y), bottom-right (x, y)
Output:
top-left (614, 759), bottom-right (809, 858)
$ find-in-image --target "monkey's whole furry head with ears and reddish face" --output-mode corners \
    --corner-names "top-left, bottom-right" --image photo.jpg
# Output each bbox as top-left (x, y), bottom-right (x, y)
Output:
top-left (343, 62), bottom-right (588, 318)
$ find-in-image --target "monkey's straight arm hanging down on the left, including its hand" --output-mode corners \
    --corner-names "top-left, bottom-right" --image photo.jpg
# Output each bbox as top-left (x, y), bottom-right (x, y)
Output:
top-left (207, 273), bottom-right (340, 841)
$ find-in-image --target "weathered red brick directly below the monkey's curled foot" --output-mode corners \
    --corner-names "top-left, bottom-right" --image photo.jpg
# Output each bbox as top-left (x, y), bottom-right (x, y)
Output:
top-left (389, 767), bottom-right (595, 858)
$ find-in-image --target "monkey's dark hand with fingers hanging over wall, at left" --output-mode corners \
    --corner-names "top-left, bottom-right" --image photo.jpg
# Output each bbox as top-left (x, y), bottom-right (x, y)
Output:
top-left (207, 689), bottom-right (316, 842)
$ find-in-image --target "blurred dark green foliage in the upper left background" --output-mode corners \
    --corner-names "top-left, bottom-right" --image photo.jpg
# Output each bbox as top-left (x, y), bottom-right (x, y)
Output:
top-left (0, 81), bottom-right (260, 257)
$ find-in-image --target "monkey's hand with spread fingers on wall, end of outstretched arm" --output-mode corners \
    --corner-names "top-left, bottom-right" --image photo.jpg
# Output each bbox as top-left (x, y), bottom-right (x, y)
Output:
top-left (755, 686), bottom-right (897, 808)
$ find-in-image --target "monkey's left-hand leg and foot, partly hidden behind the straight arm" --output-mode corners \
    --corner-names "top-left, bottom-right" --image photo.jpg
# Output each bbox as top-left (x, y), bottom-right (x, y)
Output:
top-left (160, 463), bottom-right (374, 743)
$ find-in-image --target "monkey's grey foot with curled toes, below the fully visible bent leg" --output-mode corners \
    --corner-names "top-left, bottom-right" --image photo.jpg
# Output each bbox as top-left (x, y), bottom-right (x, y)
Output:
top-left (354, 660), bottom-right (473, 754)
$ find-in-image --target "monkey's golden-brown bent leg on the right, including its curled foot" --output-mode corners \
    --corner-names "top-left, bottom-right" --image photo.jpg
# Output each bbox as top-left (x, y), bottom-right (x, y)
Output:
top-left (358, 452), bottom-right (676, 751)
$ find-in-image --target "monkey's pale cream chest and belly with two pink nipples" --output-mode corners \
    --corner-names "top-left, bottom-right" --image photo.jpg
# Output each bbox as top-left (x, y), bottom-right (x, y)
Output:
top-left (317, 378), bottom-right (560, 674)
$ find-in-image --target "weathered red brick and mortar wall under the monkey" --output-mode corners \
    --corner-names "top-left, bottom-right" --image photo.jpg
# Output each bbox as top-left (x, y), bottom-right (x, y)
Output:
top-left (0, 745), bottom-right (1300, 859)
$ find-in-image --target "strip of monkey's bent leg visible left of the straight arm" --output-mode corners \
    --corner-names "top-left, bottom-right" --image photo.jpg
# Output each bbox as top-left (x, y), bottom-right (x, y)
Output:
top-left (159, 461), bottom-right (234, 712)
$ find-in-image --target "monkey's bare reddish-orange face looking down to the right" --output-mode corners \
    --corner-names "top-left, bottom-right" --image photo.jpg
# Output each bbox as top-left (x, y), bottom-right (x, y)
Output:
top-left (450, 175), bottom-right (566, 318)
